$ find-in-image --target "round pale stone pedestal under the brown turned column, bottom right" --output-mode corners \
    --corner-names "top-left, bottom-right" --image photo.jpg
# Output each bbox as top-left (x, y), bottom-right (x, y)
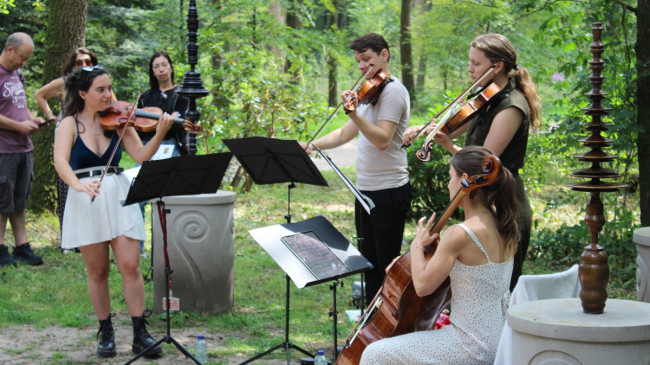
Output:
top-left (508, 298), bottom-right (650, 365)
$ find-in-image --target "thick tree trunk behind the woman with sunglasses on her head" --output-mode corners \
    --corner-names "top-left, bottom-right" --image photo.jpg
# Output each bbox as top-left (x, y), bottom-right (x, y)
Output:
top-left (28, 0), bottom-right (88, 211)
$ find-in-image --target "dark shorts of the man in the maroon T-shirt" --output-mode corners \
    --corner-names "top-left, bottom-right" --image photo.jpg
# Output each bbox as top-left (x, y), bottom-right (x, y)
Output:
top-left (0, 151), bottom-right (34, 214)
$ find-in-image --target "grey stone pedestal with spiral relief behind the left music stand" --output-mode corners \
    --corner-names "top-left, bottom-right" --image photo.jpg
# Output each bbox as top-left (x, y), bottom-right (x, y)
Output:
top-left (151, 191), bottom-right (236, 314)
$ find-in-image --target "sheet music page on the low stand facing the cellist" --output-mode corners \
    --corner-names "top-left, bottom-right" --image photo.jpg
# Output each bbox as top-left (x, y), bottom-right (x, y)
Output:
top-left (281, 231), bottom-right (350, 279)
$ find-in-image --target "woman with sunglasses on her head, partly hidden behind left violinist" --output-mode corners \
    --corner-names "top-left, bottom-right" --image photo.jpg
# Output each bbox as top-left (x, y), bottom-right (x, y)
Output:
top-left (34, 47), bottom-right (117, 253)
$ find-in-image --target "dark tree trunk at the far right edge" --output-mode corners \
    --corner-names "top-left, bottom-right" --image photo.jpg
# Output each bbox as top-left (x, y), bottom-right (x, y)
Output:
top-left (636, 0), bottom-right (650, 227)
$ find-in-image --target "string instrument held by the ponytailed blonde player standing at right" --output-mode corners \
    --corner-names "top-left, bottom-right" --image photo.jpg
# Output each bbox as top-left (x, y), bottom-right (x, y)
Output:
top-left (415, 83), bottom-right (501, 161)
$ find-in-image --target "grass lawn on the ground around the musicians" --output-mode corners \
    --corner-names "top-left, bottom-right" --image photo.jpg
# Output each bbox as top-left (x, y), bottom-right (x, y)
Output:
top-left (0, 164), bottom-right (636, 364)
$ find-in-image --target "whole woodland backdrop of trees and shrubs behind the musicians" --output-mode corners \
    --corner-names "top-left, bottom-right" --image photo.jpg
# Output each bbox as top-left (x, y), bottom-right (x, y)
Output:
top-left (0, 0), bottom-right (650, 322)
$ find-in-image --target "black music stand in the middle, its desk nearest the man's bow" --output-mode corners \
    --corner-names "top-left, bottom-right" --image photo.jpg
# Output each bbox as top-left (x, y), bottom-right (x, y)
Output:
top-left (223, 137), bottom-right (328, 365)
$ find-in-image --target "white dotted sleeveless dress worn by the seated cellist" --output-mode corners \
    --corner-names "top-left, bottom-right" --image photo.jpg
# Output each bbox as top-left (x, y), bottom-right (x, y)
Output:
top-left (361, 223), bottom-right (513, 365)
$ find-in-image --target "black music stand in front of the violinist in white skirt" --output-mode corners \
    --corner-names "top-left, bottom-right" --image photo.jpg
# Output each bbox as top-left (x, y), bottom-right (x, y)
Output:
top-left (123, 152), bottom-right (232, 365)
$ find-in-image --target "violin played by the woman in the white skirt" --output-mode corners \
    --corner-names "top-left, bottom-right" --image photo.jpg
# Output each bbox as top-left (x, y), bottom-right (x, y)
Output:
top-left (99, 101), bottom-right (201, 132)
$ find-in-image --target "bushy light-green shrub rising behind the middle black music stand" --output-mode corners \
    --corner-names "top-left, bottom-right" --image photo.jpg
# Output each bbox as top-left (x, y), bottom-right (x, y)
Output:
top-left (197, 45), bottom-right (325, 144)
